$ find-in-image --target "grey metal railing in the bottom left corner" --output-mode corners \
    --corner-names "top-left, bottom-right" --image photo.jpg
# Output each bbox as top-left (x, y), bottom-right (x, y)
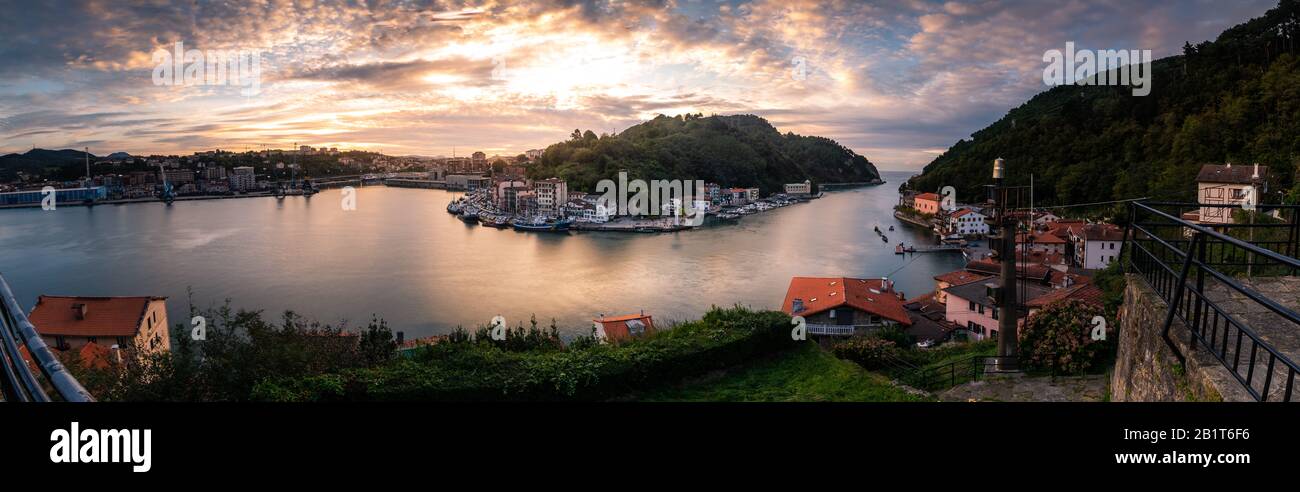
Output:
top-left (0, 270), bottom-right (95, 402)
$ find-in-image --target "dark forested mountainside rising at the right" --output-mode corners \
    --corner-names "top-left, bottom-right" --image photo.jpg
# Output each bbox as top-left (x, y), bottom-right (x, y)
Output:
top-left (906, 0), bottom-right (1300, 204)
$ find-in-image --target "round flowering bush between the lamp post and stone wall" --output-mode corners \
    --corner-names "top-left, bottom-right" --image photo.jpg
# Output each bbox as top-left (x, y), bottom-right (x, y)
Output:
top-left (1019, 299), bottom-right (1115, 374)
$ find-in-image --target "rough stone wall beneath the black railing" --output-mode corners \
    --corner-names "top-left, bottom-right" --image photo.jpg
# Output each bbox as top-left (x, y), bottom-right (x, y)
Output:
top-left (1110, 275), bottom-right (1252, 401)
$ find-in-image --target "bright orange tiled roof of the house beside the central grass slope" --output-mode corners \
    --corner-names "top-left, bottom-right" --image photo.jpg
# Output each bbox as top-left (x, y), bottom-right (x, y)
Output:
top-left (781, 277), bottom-right (911, 325)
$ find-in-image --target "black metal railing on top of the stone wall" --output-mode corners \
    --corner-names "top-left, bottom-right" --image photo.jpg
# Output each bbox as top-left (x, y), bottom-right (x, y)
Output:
top-left (1125, 202), bottom-right (1300, 401)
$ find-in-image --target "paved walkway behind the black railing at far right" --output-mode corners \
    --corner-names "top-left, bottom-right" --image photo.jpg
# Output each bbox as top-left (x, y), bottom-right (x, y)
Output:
top-left (1199, 277), bottom-right (1300, 401)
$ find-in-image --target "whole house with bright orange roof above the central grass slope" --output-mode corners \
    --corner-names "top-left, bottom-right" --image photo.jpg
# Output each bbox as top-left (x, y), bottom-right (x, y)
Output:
top-left (781, 277), bottom-right (913, 336)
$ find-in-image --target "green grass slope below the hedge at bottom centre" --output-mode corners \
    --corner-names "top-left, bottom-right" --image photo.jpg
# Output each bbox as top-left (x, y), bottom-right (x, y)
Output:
top-left (638, 344), bottom-right (928, 402)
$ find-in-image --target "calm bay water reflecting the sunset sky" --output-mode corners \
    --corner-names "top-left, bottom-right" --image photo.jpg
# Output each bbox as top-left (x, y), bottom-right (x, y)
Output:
top-left (0, 173), bottom-right (962, 336)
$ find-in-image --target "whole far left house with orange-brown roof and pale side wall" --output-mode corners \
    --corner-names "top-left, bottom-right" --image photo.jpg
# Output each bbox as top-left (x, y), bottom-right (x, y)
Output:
top-left (27, 295), bottom-right (172, 366)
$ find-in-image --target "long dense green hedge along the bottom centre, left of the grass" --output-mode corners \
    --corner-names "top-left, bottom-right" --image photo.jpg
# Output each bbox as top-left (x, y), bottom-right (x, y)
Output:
top-left (245, 307), bottom-right (793, 401)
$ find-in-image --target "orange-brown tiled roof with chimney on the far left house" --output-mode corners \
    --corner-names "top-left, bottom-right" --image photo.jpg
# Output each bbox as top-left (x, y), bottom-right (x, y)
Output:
top-left (27, 295), bottom-right (166, 337)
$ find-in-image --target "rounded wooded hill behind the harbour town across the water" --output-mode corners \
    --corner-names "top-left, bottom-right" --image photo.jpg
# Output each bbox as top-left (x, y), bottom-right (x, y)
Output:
top-left (528, 115), bottom-right (880, 194)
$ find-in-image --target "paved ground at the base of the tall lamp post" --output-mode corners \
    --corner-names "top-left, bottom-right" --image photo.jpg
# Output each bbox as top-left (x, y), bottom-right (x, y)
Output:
top-left (939, 375), bottom-right (1106, 401)
